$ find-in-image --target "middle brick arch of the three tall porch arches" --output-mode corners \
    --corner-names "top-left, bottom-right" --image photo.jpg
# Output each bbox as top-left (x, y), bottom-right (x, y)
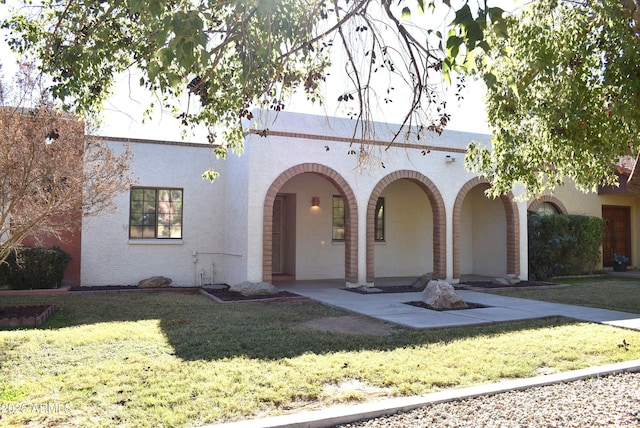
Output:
top-left (367, 170), bottom-right (447, 283)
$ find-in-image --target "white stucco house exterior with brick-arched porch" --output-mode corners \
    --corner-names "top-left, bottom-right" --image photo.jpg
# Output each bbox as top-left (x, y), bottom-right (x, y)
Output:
top-left (81, 112), bottom-right (527, 286)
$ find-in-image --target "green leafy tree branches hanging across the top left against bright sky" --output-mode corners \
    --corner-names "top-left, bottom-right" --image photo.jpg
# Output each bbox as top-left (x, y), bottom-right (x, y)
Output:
top-left (2, 0), bottom-right (502, 179)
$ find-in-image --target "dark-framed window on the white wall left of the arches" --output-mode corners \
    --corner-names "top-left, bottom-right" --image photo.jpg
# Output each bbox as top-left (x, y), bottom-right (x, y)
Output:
top-left (129, 187), bottom-right (182, 239)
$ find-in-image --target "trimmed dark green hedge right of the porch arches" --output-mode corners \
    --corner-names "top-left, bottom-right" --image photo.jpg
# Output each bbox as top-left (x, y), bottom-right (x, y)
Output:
top-left (528, 213), bottom-right (605, 279)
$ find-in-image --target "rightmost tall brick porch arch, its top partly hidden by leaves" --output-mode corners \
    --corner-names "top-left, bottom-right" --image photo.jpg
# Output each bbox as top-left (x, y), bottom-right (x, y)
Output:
top-left (452, 177), bottom-right (520, 279)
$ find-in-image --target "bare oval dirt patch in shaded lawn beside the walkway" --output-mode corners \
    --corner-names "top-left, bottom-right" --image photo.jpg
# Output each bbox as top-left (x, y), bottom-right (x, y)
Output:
top-left (296, 315), bottom-right (395, 336)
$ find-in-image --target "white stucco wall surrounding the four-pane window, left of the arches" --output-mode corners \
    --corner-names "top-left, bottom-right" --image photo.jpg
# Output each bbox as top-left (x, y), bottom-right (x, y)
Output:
top-left (81, 141), bottom-right (226, 286)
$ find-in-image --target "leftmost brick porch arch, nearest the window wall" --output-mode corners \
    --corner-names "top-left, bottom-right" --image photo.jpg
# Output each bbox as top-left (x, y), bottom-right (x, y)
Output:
top-left (262, 163), bottom-right (358, 283)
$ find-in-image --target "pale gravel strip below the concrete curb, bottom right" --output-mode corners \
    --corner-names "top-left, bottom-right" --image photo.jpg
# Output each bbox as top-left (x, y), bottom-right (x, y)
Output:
top-left (336, 372), bottom-right (640, 428)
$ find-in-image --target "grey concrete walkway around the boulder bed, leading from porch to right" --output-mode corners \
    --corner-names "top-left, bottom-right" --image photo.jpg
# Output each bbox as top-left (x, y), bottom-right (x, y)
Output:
top-left (277, 280), bottom-right (640, 330)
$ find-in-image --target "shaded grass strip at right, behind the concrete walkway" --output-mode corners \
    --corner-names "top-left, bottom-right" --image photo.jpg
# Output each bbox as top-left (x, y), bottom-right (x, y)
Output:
top-left (494, 276), bottom-right (640, 313)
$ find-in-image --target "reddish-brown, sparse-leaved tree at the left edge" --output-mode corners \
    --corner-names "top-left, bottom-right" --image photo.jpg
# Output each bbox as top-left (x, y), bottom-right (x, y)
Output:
top-left (0, 66), bottom-right (132, 263)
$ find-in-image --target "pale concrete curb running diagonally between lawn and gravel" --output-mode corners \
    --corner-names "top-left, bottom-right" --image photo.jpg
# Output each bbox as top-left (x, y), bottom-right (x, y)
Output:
top-left (202, 360), bottom-right (640, 428)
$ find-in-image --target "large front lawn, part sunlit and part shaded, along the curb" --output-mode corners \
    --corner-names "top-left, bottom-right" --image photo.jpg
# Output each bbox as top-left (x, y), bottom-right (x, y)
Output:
top-left (0, 293), bottom-right (640, 427)
